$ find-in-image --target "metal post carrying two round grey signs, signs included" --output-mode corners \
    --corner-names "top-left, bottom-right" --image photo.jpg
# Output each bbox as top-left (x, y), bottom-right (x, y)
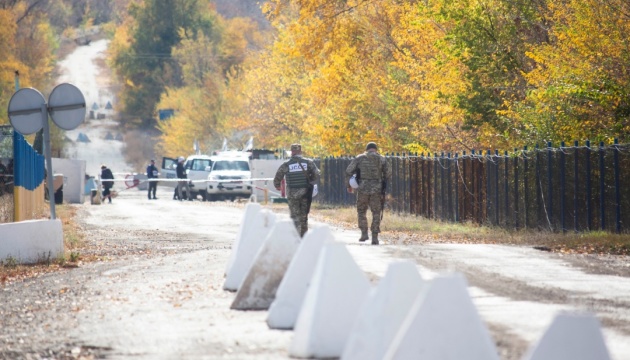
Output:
top-left (8, 84), bottom-right (86, 220)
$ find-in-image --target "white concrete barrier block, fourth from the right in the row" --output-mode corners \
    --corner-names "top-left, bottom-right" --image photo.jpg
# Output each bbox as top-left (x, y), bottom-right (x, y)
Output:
top-left (289, 243), bottom-right (370, 358)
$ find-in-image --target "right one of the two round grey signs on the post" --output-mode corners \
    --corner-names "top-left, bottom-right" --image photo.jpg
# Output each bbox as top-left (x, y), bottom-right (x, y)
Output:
top-left (48, 84), bottom-right (86, 130)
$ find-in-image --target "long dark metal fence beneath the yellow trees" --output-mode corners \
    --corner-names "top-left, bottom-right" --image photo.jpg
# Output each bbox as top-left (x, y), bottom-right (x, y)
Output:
top-left (316, 141), bottom-right (630, 233)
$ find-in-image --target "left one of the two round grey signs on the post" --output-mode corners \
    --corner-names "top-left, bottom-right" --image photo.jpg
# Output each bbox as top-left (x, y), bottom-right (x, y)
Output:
top-left (9, 88), bottom-right (48, 135)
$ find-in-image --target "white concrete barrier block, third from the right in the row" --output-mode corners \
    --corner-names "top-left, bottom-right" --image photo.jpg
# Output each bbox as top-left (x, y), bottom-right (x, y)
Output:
top-left (341, 261), bottom-right (425, 360)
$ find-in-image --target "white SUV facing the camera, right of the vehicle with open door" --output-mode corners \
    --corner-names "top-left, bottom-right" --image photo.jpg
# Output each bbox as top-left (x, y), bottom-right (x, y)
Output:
top-left (206, 152), bottom-right (253, 201)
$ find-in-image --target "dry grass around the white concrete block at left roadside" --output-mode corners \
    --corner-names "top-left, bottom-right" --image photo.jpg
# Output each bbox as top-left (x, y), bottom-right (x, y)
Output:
top-left (0, 204), bottom-right (90, 284)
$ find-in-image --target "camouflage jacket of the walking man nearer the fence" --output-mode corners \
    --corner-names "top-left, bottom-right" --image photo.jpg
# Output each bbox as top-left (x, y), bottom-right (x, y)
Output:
top-left (346, 151), bottom-right (392, 194)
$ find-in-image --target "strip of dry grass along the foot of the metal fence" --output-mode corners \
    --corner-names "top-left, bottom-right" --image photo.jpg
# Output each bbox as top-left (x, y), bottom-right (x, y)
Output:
top-left (312, 204), bottom-right (630, 255)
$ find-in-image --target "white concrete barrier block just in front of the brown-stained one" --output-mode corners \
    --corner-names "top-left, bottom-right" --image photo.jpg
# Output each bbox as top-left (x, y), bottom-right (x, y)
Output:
top-left (267, 225), bottom-right (335, 329)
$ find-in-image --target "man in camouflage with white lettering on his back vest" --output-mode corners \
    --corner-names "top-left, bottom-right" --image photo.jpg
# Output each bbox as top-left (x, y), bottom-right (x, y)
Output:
top-left (273, 144), bottom-right (319, 236)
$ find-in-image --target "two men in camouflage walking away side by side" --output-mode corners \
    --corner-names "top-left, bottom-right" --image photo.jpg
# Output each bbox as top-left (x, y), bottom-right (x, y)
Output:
top-left (273, 142), bottom-right (391, 245)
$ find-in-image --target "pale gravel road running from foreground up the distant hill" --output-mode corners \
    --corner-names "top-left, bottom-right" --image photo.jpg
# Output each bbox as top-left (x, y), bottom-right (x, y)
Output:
top-left (0, 35), bottom-right (630, 360)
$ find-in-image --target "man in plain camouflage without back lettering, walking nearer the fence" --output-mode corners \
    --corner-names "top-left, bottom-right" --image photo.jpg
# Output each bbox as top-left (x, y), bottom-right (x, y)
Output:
top-left (346, 142), bottom-right (392, 245)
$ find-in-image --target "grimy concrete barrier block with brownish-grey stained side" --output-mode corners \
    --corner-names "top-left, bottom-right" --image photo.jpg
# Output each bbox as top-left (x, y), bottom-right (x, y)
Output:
top-left (230, 220), bottom-right (300, 310)
